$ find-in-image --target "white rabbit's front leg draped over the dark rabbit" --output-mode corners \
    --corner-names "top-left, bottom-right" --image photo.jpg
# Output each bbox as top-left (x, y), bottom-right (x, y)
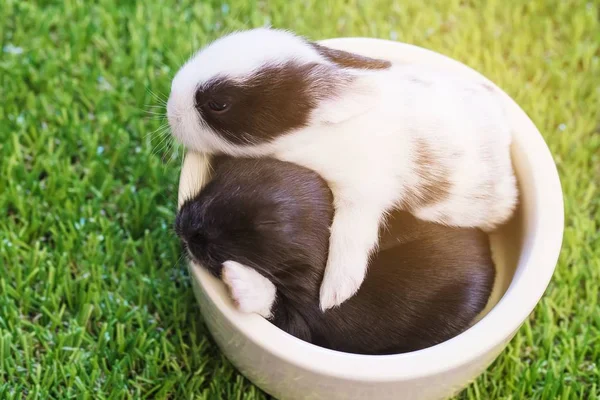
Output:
top-left (320, 194), bottom-right (385, 311)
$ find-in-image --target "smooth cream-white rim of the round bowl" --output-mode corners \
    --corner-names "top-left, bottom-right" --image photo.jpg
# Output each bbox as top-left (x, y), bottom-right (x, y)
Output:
top-left (179, 37), bottom-right (564, 382)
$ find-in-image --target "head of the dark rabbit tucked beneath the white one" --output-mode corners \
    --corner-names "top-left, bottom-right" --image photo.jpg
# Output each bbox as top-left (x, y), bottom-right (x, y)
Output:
top-left (175, 156), bottom-right (333, 282)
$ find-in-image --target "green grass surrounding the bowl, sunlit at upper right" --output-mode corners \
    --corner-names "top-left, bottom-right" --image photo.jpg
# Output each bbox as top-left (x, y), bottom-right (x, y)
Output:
top-left (0, 0), bottom-right (600, 399)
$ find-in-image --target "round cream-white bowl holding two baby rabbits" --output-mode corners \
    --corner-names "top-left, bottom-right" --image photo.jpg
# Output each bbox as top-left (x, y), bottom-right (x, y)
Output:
top-left (179, 38), bottom-right (564, 400)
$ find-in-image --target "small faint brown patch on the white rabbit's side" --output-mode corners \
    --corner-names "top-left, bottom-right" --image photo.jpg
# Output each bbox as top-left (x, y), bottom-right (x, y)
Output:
top-left (400, 139), bottom-right (452, 211)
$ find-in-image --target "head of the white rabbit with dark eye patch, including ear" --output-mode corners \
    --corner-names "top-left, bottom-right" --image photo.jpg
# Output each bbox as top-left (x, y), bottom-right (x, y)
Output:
top-left (167, 28), bottom-right (391, 155)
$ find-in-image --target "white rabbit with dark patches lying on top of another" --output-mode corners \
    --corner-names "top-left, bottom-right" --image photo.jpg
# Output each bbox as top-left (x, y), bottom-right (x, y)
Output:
top-left (167, 28), bottom-right (518, 310)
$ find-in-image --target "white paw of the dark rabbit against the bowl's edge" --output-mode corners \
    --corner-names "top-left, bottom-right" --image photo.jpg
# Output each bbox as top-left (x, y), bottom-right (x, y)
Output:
top-left (222, 261), bottom-right (277, 318)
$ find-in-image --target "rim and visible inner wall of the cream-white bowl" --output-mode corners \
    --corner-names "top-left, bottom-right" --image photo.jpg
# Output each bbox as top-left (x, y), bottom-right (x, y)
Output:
top-left (179, 38), bottom-right (563, 381)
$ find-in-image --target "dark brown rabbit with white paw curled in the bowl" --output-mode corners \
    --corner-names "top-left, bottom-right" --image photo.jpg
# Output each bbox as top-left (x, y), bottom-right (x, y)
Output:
top-left (175, 156), bottom-right (495, 355)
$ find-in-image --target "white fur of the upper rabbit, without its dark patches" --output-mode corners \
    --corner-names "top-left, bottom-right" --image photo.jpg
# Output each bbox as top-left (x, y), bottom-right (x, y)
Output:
top-left (169, 31), bottom-right (517, 310)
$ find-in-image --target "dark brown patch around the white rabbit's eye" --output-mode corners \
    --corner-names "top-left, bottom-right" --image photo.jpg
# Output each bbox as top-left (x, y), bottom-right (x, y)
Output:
top-left (195, 62), bottom-right (347, 145)
